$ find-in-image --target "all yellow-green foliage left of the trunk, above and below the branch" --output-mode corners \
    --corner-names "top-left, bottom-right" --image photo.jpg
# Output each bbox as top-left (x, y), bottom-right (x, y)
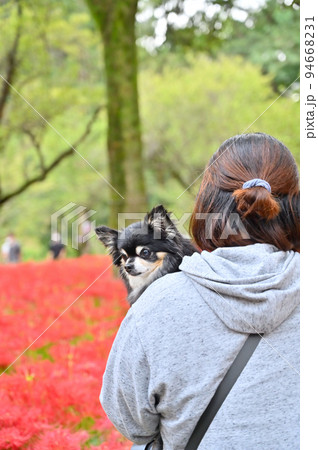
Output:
top-left (0, 0), bottom-right (106, 259)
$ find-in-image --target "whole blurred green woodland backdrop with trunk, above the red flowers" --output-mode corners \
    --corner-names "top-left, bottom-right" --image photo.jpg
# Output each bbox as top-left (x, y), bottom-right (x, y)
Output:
top-left (0, 0), bottom-right (299, 260)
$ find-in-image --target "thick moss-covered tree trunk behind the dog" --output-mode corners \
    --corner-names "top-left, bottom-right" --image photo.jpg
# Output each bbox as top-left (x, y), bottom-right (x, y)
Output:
top-left (86, 0), bottom-right (146, 225)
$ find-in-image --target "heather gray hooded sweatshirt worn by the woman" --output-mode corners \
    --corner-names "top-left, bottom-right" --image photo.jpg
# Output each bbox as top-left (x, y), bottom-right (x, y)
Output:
top-left (100, 244), bottom-right (299, 450)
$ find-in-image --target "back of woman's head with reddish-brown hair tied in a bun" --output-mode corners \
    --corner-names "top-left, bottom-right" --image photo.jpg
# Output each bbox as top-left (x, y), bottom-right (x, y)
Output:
top-left (190, 133), bottom-right (299, 251)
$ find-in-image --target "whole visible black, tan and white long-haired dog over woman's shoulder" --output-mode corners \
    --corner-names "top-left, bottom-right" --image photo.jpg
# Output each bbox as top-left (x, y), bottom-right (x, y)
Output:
top-left (95, 205), bottom-right (197, 305)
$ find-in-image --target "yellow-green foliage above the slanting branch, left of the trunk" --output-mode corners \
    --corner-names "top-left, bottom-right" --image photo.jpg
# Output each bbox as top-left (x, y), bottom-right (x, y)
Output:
top-left (0, 1), bottom-right (104, 200)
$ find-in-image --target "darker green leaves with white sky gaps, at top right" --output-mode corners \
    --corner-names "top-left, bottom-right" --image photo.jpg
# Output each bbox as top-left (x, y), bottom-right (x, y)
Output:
top-left (137, 0), bottom-right (300, 92)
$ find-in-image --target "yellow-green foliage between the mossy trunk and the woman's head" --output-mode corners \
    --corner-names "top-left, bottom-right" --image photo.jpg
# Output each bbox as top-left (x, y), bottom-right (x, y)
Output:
top-left (140, 55), bottom-right (299, 218)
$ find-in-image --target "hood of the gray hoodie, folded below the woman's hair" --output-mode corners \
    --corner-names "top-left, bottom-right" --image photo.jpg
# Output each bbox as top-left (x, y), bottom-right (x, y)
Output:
top-left (180, 244), bottom-right (299, 333)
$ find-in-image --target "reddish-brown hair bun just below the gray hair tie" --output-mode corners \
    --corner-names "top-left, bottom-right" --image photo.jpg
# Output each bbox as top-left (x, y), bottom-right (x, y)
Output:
top-left (233, 186), bottom-right (280, 220)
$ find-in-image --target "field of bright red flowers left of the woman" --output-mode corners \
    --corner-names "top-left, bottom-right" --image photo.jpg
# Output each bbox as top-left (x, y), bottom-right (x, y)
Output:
top-left (0, 255), bottom-right (131, 450)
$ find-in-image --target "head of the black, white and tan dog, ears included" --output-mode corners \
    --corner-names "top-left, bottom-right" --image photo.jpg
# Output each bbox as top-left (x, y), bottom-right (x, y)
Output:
top-left (95, 205), bottom-right (180, 279)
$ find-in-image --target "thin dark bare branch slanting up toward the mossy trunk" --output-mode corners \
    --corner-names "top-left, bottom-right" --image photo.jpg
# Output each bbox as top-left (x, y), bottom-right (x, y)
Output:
top-left (0, 106), bottom-right (104, 206)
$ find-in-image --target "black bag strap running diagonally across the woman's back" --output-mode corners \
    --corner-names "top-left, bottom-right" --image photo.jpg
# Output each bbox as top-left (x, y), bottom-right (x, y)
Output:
top-left (185, 334), bottom-right (262, 450)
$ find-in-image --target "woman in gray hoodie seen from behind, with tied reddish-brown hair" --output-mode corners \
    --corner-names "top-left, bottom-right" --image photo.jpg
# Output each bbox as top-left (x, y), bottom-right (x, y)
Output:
top-left (100, 133), bottom-right (299, 450)
